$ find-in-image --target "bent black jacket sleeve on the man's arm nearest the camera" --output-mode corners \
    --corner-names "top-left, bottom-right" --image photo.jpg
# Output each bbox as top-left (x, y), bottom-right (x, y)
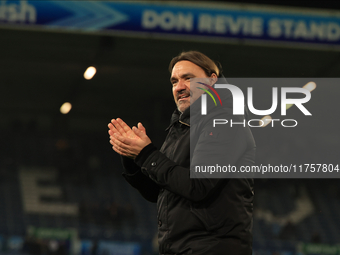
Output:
top-left (135, 114), bottom-right (255, 202)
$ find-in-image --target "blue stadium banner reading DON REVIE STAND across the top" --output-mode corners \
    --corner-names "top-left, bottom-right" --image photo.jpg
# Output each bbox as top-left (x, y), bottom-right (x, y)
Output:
top-left (0, 0), bottom-right (340, 48)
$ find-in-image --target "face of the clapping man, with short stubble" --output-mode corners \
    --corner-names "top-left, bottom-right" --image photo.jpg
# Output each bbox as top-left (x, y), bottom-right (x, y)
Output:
top-left (170, 60), bottom-right (216, 112)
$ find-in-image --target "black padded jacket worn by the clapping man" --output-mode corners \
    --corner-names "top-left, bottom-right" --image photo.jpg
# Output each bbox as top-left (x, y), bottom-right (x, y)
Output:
top-left (123, 86), bottom-right (255, 255)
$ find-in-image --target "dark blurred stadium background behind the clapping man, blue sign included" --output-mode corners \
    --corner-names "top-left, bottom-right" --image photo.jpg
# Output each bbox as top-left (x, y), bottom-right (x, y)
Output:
top-left (0, 0), bottom-right (340, 255)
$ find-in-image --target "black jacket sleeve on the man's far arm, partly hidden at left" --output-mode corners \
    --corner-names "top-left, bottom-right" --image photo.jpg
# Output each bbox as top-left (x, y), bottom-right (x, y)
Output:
top-left (121, 157), bottom-right (159, 203)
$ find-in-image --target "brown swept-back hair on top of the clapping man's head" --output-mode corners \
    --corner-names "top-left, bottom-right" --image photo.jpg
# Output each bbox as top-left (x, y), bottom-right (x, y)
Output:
top-left (169, 51), bottom-right (221, 77)
